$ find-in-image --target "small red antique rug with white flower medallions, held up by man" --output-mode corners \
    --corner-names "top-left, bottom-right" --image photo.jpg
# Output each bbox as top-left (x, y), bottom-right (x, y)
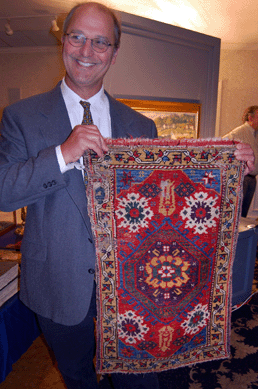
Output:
top-left (84, 139), bottom-right (244, 374)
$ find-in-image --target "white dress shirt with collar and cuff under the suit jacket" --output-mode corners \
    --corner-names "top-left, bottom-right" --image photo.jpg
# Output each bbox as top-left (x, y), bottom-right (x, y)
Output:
top-left (56, 79), bottom-right (111, 173)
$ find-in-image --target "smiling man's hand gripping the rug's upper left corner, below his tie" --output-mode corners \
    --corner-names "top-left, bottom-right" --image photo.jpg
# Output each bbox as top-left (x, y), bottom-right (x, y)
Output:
top-left (61, 124), bottom-right (108, 164)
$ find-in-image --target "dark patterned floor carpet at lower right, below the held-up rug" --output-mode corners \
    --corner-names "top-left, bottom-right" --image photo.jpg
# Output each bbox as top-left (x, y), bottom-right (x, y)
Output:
top-left (158, 292), bottom-right (258, 389)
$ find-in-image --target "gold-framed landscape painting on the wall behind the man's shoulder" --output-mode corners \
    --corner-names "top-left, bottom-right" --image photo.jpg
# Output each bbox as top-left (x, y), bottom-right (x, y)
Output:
top-left (117, 98), bottom-right (201, 139)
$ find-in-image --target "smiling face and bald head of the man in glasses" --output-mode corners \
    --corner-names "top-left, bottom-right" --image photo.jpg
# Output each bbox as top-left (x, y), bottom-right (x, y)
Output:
top-left (63, 6), bottom-right (117, 99)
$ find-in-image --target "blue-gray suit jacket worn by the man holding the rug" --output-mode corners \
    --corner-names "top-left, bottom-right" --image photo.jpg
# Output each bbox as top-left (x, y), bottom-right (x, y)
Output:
top-left (0, 84), bottom-right (157, 325)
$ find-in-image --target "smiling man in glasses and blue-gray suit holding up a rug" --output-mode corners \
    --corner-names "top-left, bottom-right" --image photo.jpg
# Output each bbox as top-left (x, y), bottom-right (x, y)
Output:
top-left (0, 3), bottom-right (253, 389)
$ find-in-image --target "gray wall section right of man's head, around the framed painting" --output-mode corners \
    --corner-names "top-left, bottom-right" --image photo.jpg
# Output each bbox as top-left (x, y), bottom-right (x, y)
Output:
top-left (105, 12), bottom-right (220, 137)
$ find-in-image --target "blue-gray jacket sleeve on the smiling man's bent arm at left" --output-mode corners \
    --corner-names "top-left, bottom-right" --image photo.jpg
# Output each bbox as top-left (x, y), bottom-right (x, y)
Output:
top-left (0, 104), bottom-right (67, 212)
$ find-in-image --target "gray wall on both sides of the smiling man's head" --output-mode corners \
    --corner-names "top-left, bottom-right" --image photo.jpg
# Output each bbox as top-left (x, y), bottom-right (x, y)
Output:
top-left (0, 12), bottom-right (220, 137)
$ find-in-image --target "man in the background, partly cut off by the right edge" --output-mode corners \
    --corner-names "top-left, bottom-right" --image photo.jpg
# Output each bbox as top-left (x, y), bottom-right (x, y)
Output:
top-left (224, 105), bottom-right (258, 217)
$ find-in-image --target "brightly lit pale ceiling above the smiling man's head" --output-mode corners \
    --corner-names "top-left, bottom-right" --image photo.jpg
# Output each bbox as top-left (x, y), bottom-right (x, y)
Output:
top-left (0, 0), bottom-right (258, 51)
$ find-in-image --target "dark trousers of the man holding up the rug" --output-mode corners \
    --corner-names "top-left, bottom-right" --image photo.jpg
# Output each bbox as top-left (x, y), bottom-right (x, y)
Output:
top-left (38, 284), bottom-right (159, 389)
